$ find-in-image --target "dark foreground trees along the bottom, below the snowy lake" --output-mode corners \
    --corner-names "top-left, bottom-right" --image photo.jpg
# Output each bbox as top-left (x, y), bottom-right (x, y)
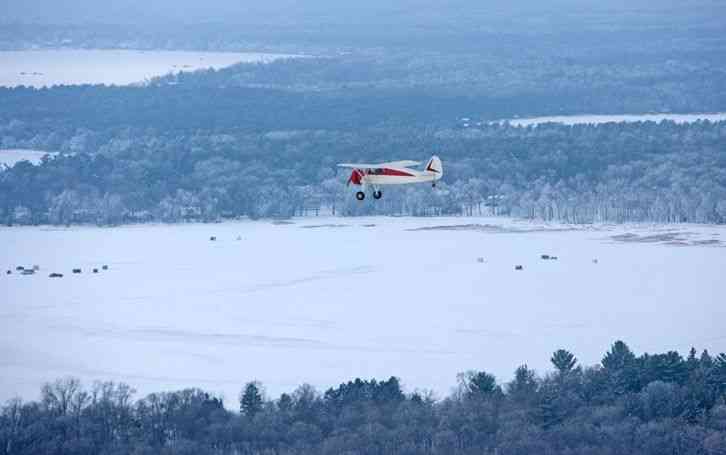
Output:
top-left (0, 341), bottom-right (726, 455)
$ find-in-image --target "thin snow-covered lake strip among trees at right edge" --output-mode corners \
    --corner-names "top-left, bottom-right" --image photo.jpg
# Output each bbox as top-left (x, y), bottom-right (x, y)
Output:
top-left (491, 112), bottom-right (726, 126)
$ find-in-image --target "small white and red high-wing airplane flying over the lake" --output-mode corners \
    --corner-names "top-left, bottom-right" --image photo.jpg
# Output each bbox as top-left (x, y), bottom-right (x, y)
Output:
top-left (338, 155), bottom-right (444, 201)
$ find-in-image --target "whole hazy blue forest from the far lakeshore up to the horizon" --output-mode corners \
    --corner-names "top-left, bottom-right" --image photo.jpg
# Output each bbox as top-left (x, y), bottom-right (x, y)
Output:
top-left (0, 0), bottom-right (726, 225)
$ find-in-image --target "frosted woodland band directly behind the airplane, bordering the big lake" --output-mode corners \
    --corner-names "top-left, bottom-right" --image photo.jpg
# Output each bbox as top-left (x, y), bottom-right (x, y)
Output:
top-left (0, 121), bottom-right (726, 224)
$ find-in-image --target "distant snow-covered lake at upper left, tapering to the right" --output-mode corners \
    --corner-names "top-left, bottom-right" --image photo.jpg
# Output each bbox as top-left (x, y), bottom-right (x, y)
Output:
top-left (0, 49), bottom-right (297, 87)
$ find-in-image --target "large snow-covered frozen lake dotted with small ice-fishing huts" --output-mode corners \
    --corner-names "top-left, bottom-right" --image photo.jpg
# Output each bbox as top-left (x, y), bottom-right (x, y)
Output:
top-left (0, 218), bottom-right (726, 407)
